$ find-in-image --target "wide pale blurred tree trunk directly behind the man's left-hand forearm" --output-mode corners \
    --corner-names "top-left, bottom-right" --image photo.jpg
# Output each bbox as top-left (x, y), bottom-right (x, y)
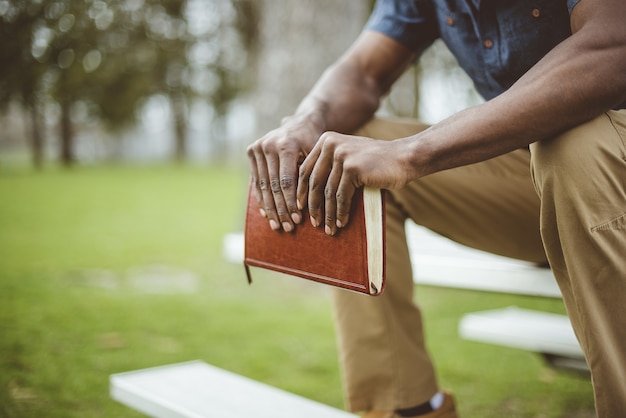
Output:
top-left (251, 0), bottom-right (371, 139)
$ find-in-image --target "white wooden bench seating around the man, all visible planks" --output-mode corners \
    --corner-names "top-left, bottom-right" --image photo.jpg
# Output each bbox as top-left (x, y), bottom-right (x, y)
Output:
top-left (110, 222), bottom-right (587, 418)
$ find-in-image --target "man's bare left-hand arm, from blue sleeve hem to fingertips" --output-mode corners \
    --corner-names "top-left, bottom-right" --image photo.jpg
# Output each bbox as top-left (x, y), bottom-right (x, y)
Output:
top-left (248, 32), bottom-right (414, 235)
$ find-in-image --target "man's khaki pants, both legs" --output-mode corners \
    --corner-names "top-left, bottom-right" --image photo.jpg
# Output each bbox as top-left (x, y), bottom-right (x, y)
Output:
top-left (333, 111), bottom-right (626, 418)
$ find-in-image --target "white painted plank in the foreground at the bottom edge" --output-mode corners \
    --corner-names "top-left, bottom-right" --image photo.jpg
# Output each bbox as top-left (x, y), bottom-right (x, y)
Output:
top-left (110, 360), bottom-right (356, 418)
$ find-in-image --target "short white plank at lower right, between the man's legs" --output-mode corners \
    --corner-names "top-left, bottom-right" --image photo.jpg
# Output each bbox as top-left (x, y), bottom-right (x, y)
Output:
top-left (459, 306), bottom-right (583, 359)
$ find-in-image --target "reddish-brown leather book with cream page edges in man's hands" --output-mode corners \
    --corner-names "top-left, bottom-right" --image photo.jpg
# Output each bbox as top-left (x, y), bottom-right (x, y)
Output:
top-left (244, 188), bottom-right (385, 295)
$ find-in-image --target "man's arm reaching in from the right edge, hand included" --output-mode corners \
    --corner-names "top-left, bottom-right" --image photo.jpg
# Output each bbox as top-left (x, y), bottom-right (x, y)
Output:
top-left (298, 0), bottom-right (626, 233)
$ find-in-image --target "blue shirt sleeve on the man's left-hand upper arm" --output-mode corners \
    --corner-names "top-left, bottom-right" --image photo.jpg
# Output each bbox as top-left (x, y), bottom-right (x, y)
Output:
top-left (365, 0), bottom-right (436, 54)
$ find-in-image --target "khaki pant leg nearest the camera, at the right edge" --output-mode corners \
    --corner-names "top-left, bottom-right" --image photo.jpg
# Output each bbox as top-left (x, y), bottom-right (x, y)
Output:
top-left (531, 110), bottom-right (626, 418)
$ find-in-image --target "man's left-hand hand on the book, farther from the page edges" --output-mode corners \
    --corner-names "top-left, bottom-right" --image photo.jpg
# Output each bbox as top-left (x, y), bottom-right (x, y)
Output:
top-left (247, 116), bottom-right (322, 232)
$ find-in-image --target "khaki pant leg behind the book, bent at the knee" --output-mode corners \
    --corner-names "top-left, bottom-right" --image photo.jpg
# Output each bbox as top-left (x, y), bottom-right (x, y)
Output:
top-left (333, 119), bottom-right (545, 411)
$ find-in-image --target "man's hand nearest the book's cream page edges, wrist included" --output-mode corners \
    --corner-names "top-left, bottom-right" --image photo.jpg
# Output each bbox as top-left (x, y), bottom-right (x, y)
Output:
top-left (297, 132), bottom-right (412, 235)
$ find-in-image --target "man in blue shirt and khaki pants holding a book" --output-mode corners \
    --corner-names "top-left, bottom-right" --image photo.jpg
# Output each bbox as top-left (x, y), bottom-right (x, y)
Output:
top-left (248, 0), bottom-right (626, 418)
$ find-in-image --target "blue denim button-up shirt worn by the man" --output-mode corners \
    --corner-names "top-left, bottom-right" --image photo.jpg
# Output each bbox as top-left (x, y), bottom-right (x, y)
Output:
top-left (366, 0), bottom-right (580, 99)
